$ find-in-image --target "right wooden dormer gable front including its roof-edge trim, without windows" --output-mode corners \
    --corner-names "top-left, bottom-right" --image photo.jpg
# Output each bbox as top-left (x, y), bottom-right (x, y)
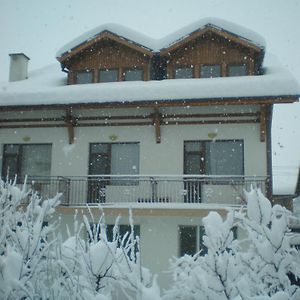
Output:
top-left (160, 26), bottom-right (263, 78)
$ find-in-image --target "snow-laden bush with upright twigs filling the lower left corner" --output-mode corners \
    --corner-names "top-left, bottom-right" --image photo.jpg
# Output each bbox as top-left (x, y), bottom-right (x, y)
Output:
top-left (0, 181), bottom-right (160, 300)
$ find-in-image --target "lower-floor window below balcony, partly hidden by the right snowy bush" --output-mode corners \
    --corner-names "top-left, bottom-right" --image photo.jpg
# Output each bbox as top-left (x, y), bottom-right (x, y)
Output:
top-left (179, 225), bottom-right (237, 256)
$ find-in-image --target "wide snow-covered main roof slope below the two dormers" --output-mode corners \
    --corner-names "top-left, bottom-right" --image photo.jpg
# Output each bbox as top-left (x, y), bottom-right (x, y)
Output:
top-left (0, 54), bottom-right (300, 106)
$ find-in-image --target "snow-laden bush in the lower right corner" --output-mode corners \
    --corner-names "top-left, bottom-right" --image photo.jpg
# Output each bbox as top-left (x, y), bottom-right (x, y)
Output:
top-left (165, 189), bottom-right (300, 300)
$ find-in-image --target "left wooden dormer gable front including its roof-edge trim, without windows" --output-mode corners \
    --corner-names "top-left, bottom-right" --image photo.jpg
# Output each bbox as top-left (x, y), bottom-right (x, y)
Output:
top-left (58, 32), bottom-right (152, 84)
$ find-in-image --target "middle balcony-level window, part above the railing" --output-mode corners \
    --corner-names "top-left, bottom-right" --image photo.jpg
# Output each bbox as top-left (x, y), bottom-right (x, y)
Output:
top-left (89, 143), bottom-right (139, 175)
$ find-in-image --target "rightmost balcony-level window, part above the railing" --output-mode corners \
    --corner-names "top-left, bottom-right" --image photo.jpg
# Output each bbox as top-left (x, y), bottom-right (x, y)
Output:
top-left (184, 140), bottom-right (244, 175)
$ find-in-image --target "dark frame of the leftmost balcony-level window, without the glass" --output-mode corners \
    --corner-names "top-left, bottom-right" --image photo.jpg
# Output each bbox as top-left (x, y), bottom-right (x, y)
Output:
top-left (1, 143), bottom-right (52, 183)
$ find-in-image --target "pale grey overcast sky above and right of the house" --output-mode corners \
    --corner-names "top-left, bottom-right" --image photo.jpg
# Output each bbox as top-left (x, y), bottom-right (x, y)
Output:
top-left (0, 0), bottom-right (300, 186)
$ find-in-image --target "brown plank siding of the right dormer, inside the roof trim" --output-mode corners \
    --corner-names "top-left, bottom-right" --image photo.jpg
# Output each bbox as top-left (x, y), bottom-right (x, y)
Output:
top-left (167, 33), bottom-right (258, 78)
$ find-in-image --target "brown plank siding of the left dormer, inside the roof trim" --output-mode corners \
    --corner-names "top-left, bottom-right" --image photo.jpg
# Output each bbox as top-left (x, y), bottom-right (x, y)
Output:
top-left (65, 40), bottom-right (150, 84)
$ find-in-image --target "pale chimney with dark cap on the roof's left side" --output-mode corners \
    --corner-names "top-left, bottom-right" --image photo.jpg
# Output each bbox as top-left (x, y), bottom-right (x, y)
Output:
top-left (9, 53), bottom-right (29, 81)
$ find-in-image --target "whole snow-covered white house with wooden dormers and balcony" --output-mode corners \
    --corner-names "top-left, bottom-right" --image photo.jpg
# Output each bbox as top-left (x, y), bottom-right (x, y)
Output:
top-left (0, 19), bottom-right (299, 286)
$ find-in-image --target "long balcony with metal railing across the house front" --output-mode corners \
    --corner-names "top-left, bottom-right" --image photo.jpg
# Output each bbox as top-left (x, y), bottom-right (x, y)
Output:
top-left (22, 175), bottom-right (268, 206)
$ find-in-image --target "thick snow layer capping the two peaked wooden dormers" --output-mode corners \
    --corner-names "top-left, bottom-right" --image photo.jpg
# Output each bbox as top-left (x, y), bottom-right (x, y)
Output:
top-left (56, 18), bottom-right (265, 57)
